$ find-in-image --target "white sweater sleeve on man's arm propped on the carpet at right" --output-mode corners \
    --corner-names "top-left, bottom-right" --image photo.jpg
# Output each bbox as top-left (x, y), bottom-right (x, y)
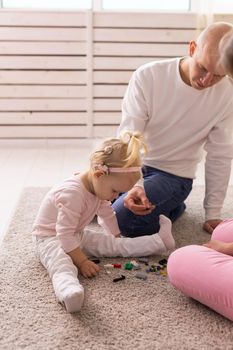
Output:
top-left (204, 109), bottom-right (233, 220)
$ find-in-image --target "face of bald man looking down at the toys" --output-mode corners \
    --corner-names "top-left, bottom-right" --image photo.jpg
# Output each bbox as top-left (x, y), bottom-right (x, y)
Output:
top-left (189, 42), bottom-right (226, 90)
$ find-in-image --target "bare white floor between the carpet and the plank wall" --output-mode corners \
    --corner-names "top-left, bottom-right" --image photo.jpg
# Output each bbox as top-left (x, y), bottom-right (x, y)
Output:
top-left (0, 139), bottom-right (233, 243)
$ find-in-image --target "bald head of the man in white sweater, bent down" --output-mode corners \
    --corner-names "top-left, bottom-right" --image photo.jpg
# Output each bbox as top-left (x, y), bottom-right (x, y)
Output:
top-left (181, 22), bottom-right (233, 90)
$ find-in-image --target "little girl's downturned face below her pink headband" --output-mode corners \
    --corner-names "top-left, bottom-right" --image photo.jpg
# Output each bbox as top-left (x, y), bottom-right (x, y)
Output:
top-left (92, 172), bottom-right (141, 201)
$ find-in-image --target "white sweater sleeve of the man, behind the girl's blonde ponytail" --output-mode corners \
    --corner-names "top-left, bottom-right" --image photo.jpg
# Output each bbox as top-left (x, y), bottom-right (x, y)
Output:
top-left (118, 71), bottom-right (148, 134)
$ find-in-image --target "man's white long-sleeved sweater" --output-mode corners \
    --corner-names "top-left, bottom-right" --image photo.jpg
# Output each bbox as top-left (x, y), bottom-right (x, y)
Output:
top-left (119, 58), bottom-right (233, 220)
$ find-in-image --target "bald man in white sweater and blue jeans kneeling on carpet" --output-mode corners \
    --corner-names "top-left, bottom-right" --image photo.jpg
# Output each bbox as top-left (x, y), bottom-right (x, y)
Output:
top-left (113, 22), bottom-right (233, 237)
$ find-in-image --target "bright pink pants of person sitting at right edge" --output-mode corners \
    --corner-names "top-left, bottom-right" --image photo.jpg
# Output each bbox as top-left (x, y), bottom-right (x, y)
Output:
top-left (167, 219), bottom-right (233, 320)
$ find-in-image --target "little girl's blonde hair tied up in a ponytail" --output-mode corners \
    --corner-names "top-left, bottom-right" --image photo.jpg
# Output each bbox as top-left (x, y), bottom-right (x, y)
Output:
top-left (90, 131), bottom-right (147, 168)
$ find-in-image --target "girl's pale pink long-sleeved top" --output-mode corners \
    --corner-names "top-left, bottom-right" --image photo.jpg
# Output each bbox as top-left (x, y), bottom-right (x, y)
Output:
top-left (33, 175), bottom-right (120, 252)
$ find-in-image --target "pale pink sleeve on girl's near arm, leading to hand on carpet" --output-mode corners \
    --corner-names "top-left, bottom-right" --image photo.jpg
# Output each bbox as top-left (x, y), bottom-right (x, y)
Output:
top-left (55, 188), bottom-right (81, 253)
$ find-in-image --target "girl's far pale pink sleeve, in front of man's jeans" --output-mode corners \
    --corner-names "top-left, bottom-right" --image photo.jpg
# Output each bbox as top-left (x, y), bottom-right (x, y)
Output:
top-left (97, 201), bottom-right (120, 236)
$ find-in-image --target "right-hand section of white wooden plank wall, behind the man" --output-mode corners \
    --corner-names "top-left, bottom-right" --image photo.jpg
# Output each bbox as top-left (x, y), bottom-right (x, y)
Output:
top-left (93, 12), bottom-right (197, 137)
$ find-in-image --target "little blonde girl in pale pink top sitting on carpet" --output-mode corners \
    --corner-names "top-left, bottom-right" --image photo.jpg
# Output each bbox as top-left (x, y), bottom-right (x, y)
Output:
top-left (33, 132), bottom-right (175, 312)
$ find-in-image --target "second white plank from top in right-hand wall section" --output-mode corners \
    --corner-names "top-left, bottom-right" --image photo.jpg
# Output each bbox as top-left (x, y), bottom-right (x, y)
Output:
top-left (94, 28), bottom-right (197, 43)
